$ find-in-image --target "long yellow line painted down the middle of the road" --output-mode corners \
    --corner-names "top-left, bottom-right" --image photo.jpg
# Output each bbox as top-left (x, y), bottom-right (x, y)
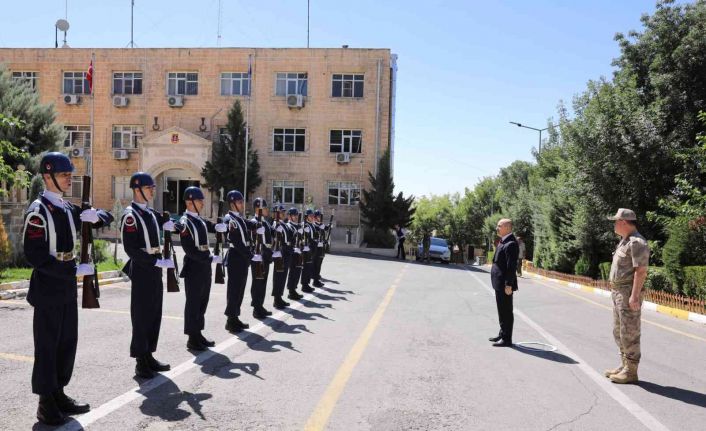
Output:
top-left (304, 264), bottom-right (409, 431)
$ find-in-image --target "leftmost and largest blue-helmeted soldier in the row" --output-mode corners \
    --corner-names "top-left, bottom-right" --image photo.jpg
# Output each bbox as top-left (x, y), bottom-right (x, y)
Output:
top-left (23, 152), bottom-right (113, 425)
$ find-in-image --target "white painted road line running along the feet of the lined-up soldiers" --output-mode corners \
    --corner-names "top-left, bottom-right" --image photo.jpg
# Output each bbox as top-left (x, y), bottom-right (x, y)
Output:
top-left (57, 294), bottom-right (315, 431)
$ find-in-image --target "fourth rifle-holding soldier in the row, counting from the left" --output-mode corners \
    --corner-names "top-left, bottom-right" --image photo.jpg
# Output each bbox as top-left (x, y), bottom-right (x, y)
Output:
top-left (223, 190), bottom-right (253, 334)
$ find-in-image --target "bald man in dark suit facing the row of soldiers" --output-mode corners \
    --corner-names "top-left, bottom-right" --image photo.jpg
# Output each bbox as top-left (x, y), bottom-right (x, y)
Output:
top-left (489, 219), bottom-right (520, 347)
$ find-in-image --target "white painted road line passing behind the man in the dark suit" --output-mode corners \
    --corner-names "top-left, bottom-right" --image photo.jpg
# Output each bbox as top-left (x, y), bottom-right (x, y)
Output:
top-left (468, 271), bottom-right (669, 431)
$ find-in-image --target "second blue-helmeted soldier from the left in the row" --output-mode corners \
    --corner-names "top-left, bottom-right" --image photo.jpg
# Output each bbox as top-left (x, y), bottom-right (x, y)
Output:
top-left (120, 172), bottom-right (174, 379)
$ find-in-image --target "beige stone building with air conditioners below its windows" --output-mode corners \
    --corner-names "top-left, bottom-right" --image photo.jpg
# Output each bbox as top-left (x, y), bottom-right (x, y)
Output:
top-left (0, 48), bottom-right (396, 233)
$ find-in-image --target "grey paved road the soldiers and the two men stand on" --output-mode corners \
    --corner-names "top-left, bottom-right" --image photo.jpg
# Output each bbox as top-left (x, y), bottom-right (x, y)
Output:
top-left (0, 256), bottom-right (706, 430)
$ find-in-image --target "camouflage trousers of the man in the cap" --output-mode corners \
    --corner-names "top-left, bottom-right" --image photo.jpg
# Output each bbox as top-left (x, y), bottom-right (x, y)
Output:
top-left (612, 285), bottom-right (643, 362)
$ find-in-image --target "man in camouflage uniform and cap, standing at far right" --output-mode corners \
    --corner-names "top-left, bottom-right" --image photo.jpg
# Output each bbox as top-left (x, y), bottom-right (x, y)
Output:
top-left (605, 208), bottom-right (650, 383)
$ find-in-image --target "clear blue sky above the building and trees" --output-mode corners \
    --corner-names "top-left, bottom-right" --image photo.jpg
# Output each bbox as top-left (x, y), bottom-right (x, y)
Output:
top-left (0, 0), bottom-right (655, 196)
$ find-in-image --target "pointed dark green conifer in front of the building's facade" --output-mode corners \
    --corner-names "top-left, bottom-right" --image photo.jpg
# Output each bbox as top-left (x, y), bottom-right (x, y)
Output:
top-left (201, 100), bottom-right (262, 197)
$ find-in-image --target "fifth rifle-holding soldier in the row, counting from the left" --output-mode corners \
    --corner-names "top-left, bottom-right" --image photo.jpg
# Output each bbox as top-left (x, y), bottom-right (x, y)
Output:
top-left (250, 198), bottom-right (273, 319)
